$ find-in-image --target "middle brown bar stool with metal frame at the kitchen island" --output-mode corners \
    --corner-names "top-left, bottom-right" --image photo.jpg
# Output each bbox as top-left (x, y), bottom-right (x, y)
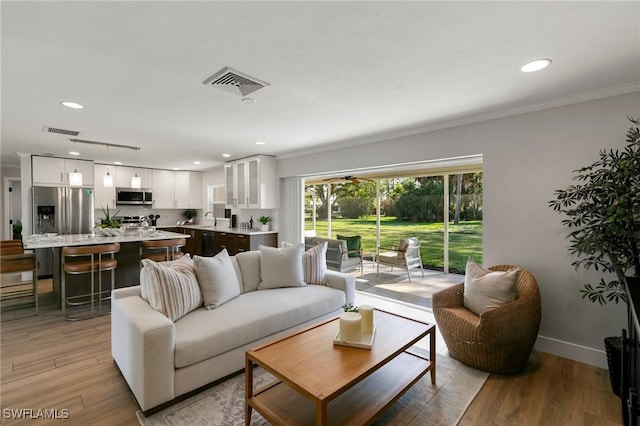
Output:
top-left (61, 243), bottom-right (120, 321)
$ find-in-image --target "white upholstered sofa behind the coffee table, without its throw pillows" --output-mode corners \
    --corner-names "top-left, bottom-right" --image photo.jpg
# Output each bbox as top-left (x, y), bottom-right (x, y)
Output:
top-left (111, 251), bottom-right (355, 415)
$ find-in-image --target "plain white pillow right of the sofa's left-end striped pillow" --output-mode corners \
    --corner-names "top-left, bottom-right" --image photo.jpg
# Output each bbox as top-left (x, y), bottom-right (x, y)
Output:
top-left (193, 249), bottom-right (240, 309)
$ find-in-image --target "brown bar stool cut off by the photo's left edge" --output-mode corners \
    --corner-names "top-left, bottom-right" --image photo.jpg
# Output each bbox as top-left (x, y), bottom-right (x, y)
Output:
top-left (0, 240), bottom-right (38, 315)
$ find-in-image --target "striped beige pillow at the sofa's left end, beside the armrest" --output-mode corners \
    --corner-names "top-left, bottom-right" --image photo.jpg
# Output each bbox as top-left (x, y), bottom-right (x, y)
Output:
top-left (141, 259), bottom-right (202, 321)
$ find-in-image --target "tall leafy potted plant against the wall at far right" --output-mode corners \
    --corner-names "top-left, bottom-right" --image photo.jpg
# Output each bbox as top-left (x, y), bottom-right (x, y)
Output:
top-left (549, 117), bottom-right (640, 396)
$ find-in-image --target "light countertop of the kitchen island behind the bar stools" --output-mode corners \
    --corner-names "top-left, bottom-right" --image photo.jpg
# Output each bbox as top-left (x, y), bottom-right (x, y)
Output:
top-left (23, 231), bottom-right (191, 250)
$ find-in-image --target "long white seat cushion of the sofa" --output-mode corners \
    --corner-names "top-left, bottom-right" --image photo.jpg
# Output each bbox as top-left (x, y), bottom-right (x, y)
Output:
top-left (175, 285), bottom-right (346, 368)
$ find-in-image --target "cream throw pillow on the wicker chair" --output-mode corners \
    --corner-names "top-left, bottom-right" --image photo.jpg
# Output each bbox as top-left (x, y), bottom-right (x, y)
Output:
top-left (463, 258), bottom-right (518, 315)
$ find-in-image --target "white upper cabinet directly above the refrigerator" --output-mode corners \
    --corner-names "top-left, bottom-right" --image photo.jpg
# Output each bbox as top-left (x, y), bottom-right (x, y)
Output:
top-left (31, 155), bottom-right (93, 188)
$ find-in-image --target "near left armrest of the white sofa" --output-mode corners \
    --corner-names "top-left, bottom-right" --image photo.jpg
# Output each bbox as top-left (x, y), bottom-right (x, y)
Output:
top-left (111, 289), bottom-right (175, 411)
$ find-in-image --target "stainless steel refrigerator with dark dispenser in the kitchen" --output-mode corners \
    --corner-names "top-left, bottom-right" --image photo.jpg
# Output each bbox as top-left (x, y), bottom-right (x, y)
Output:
top-left (33, 186), bottom-right (94, 277)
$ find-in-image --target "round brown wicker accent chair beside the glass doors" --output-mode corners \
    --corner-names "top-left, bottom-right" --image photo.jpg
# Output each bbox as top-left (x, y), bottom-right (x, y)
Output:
top-left (433, 265), bottom-right (542, 374)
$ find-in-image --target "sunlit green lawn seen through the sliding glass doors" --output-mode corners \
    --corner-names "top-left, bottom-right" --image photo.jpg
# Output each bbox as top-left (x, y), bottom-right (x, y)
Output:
top-left (305, 216), bottom-right (482, 272)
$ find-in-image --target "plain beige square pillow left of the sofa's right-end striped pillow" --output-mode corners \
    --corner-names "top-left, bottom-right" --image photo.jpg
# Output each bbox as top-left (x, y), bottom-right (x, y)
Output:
top-left (258, 244), bottom-right (306, 290)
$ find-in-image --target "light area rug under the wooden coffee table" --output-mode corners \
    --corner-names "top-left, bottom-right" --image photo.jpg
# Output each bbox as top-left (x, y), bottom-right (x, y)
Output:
top-left (137, 355), bottom-right (489, 426)
